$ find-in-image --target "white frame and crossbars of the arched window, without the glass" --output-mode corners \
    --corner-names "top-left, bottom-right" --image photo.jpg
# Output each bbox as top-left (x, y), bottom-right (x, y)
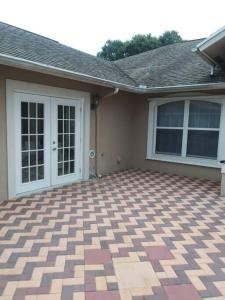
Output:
top-left (147, 95), bottom-right (225, 168)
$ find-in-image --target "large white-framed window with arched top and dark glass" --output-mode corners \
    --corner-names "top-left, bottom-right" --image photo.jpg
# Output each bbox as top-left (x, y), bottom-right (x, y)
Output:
top-left (147, 99), bottom-right (225, 166)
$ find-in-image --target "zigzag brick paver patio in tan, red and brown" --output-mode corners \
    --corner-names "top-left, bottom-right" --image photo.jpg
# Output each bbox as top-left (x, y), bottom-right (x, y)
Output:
top-left (0, 170), bottom-right (225, 300)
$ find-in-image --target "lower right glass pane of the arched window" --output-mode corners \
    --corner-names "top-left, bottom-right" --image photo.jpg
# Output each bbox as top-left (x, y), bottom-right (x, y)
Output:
top-left (187, 130), bottom-right (219, 159)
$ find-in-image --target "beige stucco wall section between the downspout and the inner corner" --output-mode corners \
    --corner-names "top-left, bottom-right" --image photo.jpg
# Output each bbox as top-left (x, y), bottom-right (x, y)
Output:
top-left (97, 92), bottom-right (133, 174)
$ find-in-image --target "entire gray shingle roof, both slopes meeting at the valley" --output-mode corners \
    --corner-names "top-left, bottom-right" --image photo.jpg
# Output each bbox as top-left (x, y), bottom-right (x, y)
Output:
top-left (0, 22), bottom-right (225, 87)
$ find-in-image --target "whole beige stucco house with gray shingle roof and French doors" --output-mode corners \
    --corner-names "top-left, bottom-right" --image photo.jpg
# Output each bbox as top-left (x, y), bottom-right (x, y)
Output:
top-left (0, 23), bottom-right (225, 200)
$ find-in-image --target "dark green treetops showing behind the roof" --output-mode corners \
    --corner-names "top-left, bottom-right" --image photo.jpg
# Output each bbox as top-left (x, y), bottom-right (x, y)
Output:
top-left (97, 30), bottom-right (182, 61)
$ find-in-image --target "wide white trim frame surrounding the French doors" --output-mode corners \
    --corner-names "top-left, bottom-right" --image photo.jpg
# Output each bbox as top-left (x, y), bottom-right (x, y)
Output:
top-left (6, 79), bottom-right (90, 199)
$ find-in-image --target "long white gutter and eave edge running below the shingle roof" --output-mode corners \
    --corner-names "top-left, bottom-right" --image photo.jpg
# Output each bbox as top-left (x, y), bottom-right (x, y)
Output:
top-left (0, 53), bottom-right (225, 94)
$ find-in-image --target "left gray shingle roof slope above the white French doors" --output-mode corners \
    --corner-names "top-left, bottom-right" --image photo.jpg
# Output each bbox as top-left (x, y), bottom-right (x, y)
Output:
top-left (0, 22), bottom-right (135, 85)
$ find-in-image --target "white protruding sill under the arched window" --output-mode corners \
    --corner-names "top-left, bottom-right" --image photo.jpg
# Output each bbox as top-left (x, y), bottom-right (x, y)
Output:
top-left (146, 154), bottom-right (221, 169)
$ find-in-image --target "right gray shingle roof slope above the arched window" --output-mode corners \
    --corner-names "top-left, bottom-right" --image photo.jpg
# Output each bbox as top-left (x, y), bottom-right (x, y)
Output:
top-left (115, 39), bottom-right (225, 87)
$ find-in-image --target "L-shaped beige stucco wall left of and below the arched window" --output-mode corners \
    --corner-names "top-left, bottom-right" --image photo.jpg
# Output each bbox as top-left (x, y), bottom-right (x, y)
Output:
top-left (132, 96), bottom-right (221, 180)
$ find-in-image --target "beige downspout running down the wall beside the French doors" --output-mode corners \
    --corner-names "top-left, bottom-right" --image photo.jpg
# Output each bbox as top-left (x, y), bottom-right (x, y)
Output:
top-left (95, 88), bottom-right (119, 177)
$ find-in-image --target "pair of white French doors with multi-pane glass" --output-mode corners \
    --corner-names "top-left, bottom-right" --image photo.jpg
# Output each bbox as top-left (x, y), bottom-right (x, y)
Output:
top-left (15, 93), bottom-right (81, 194)
